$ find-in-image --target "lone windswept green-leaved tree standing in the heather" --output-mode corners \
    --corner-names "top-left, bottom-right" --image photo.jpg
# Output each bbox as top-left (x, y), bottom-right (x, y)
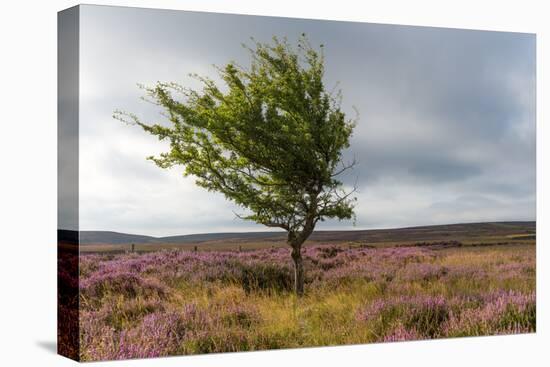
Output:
top-left (114, 34), bottom-right (356, 296)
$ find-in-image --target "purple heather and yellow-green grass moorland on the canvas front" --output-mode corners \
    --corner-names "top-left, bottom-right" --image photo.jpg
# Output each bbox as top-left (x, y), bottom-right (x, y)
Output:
top-left (75, 245), bottom-right (536, 361)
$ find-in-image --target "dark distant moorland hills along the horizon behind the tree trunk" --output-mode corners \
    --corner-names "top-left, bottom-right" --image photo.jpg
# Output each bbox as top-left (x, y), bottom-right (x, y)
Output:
top-left (80, 221), bottom-right (536, 245)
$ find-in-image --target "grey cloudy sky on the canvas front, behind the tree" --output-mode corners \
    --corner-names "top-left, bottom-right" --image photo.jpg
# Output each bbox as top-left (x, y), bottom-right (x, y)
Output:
top-left (75, 6), bottom-right (535, 236)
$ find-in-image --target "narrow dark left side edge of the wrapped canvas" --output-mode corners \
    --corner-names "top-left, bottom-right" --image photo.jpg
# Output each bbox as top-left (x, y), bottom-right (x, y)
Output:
top-left (57, 7), bottom-right (79, 360)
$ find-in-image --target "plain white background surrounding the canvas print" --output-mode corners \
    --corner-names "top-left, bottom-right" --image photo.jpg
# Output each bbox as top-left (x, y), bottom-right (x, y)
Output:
top-left (0, 0), bottom-right (550, 367)
